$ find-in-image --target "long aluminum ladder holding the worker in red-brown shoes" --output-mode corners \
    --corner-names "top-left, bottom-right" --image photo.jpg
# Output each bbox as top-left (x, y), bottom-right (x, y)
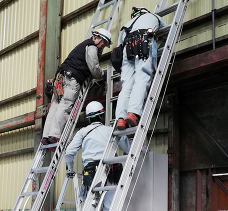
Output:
top-left (82, 0), bottom-right (189, 211)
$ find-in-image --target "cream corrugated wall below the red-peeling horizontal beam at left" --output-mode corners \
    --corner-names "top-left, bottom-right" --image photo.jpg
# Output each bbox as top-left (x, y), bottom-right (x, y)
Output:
top-left (0, 126), bottom-right (34, 210)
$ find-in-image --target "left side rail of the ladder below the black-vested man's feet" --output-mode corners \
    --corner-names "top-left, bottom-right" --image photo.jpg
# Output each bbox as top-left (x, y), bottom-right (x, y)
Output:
top-left (13, 143), bottom-right (46, 211)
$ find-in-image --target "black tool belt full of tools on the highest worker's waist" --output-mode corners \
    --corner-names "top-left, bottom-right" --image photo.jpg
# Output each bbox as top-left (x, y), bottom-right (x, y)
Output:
top-left (125, 29), bottom-right (155, 61)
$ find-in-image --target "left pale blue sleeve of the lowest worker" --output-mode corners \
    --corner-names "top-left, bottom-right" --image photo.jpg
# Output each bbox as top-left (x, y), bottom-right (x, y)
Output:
top-left (65, 130), bottom-right (83, 171)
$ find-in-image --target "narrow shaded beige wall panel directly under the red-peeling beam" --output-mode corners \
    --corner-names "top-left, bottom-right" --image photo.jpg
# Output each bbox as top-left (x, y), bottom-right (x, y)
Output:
top-left (0, 125), bottom-right (34, 154)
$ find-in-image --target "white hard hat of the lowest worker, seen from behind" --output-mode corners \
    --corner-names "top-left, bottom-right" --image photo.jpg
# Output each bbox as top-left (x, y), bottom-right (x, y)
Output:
top-left (86, 101), bottom-right (104, 118)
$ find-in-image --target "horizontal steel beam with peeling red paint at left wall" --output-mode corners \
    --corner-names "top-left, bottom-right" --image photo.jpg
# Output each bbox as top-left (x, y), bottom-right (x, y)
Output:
top-left (0, 112), bottom-right (35, 133)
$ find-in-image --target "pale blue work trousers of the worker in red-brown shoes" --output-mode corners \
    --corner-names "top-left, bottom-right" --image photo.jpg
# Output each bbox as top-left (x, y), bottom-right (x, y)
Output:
top-left (116, 38), bottom-right (157, 119)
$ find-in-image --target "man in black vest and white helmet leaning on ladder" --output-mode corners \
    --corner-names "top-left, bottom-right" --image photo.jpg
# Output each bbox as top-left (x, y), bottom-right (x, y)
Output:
top-left (41, 28), bottom-right (112, 151)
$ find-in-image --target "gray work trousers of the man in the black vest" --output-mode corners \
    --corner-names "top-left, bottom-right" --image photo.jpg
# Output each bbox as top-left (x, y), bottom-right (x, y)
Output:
top-left (43, 76), bottom-right (81, 138)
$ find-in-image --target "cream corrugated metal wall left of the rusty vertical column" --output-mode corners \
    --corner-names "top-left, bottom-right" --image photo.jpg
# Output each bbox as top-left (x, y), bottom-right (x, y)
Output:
top-left (0, 0), bottom-right (40, 210)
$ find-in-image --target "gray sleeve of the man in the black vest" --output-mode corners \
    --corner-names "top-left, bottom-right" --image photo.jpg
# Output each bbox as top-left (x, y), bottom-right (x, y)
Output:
top-left (86, 45), bottom-right (104, 79)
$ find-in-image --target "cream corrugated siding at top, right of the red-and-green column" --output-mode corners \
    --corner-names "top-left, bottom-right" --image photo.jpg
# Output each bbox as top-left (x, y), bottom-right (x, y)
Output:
top-left (61, 0), bottom-right (228, 62)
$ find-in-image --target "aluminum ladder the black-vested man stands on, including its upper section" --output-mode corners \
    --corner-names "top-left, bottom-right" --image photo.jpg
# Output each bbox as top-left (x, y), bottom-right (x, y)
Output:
top-left (13, 0), bottom-right (123, 211)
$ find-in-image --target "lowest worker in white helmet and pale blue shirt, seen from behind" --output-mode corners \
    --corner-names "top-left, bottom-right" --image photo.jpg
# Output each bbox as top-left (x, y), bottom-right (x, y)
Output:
top-left (65, 101), bottom-right (130, 211)
